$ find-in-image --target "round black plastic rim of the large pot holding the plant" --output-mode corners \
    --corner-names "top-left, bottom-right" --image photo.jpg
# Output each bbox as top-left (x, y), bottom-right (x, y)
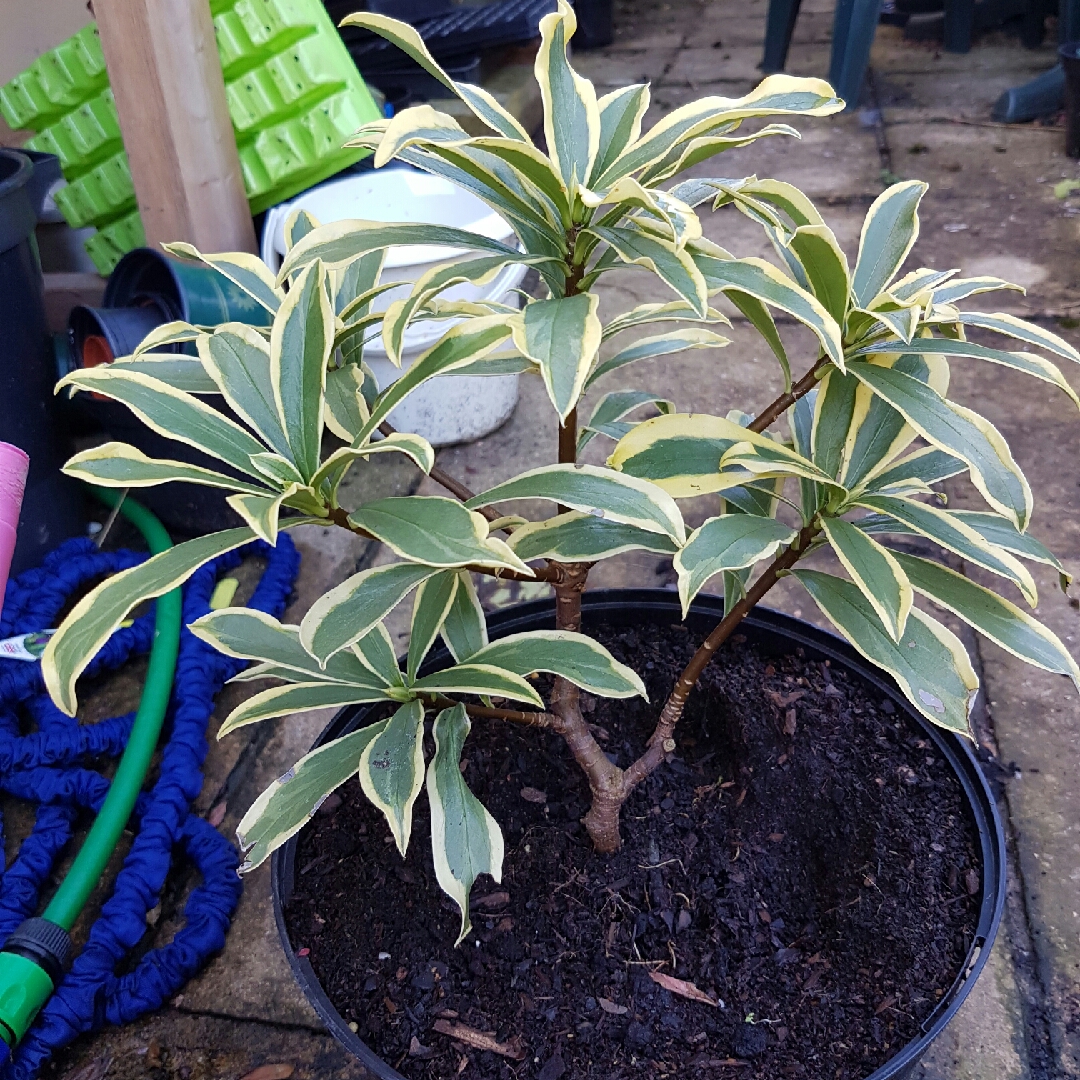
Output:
top-left (271, 589), bottom-right (1005, 1080)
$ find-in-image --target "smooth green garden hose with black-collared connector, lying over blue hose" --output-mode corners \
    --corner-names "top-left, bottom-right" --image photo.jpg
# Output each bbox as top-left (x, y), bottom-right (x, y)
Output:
top-left (0, 487), bottom-right (183, 1063)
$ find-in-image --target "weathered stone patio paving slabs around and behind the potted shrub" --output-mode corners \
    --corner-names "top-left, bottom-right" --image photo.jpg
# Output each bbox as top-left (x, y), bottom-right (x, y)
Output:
top-left (27, 0), bottom-right (1080, 1080)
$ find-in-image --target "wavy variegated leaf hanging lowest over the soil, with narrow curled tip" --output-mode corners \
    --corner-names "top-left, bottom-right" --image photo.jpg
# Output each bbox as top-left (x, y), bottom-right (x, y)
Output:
top-left (428, 705), bottom-right (503, 945)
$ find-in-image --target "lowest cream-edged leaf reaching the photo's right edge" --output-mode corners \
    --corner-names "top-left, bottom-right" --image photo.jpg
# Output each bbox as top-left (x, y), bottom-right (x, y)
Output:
top-left (896, 552), bottom-right (1080, 690)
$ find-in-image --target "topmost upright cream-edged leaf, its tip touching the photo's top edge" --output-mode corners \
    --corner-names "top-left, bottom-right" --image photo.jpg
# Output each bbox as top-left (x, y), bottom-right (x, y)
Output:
top-left (535, 0), bottom-right (600, 193)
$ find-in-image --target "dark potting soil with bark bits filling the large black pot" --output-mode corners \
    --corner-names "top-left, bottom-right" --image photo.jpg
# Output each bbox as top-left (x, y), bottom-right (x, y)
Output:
top-left (286, 626), bottom-right (981, 1080)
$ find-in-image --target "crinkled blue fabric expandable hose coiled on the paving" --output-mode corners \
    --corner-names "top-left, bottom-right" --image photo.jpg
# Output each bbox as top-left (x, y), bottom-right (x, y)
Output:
top-left (0, 501), bottom-right (299, 1080)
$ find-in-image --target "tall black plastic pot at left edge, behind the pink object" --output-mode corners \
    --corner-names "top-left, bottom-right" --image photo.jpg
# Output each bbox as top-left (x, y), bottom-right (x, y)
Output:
top-left (0, 150), bottom-right (82, 575)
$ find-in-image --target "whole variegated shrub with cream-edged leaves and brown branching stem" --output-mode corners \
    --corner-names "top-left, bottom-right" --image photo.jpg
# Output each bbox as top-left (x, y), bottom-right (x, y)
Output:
top-left (44, 0), bottom-right (1080, 935)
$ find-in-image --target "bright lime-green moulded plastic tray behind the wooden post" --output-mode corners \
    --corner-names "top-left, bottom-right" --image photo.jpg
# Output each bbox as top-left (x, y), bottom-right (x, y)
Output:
top-left (0, 0), bottom-right (379, 273)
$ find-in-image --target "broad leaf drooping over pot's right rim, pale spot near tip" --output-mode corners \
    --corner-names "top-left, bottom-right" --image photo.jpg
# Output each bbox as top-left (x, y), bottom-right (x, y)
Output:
top-left (792, 568), bottom-right (978, 739)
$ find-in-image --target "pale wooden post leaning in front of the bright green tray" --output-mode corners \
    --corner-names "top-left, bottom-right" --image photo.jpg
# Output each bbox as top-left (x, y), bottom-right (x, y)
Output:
top-left (94, 0), bottom-right (258, 253)
